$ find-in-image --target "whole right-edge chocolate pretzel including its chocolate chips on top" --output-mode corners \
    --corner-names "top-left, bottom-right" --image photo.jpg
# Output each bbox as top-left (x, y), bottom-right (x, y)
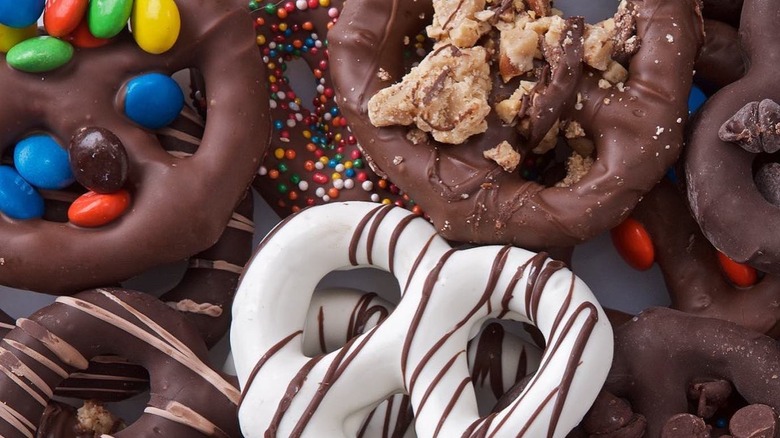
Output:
top-left (684, 0), bottom-right (780, 273)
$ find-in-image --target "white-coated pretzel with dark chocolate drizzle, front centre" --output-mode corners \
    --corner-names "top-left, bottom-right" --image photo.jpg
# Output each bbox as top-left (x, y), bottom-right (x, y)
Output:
top-left (231, 202), bottom-right (613, 437)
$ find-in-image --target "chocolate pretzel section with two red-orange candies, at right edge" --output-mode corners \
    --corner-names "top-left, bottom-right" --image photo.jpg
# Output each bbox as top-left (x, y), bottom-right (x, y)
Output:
top-left (612, 181), bottom-right (780, 337)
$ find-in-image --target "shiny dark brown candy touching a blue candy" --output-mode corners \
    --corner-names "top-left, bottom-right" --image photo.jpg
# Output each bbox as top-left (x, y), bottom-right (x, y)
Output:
top-left (68, 127), bottom-right (128, 193)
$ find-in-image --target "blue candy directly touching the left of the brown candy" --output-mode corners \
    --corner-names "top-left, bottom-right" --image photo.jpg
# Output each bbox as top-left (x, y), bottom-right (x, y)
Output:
top-left (14, 134), bottom-right (75, 190)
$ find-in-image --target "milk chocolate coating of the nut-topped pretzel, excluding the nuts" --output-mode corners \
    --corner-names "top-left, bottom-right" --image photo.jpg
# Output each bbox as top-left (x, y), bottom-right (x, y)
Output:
top-left (329, 0), bottom-right (703, 248)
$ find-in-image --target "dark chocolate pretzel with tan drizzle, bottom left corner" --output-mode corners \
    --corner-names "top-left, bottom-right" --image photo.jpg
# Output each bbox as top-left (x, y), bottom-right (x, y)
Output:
top-left (0, 289), bottom-right (239, 438)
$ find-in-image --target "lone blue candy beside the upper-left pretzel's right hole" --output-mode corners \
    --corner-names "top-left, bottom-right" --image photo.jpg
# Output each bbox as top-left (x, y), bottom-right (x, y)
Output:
top-left (124, 73), bottom-right (184, 129)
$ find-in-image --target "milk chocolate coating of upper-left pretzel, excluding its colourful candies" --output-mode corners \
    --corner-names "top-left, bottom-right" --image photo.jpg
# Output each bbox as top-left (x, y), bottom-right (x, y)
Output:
top-left (0, 0), bottom-right (269, 294)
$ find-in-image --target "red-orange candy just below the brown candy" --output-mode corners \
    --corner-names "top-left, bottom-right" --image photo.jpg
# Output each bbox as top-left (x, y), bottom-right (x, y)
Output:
top-left (68, 190), bottom-right (130, 228)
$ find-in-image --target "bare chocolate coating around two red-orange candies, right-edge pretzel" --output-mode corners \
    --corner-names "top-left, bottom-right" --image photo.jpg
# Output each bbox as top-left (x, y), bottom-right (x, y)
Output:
top-left (631, 180), bottom-right (780, 337)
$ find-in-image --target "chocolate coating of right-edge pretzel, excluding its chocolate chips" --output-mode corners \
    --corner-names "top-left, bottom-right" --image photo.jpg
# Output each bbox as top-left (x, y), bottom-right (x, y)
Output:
top-left (685, 0), bottom-right (780, 273)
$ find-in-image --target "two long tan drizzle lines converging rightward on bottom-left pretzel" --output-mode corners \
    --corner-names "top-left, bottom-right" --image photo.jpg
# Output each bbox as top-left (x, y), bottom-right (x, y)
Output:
top-left (56, 296), bottom-right (240, 404)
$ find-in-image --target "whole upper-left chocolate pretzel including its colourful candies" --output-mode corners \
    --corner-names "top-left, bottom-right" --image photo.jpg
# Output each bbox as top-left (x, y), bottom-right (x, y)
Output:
top-left (0, 0), bottom-right (270, 294)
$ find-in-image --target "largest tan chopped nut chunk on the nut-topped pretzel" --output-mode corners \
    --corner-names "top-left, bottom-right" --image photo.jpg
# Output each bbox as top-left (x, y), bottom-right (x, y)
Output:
top-left (368, 45), bottom-right (492, 144)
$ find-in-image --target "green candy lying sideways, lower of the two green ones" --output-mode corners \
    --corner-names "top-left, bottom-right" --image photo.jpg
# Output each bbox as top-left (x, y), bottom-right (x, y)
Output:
top-left (5, 36), bottom-right (73, 73)
